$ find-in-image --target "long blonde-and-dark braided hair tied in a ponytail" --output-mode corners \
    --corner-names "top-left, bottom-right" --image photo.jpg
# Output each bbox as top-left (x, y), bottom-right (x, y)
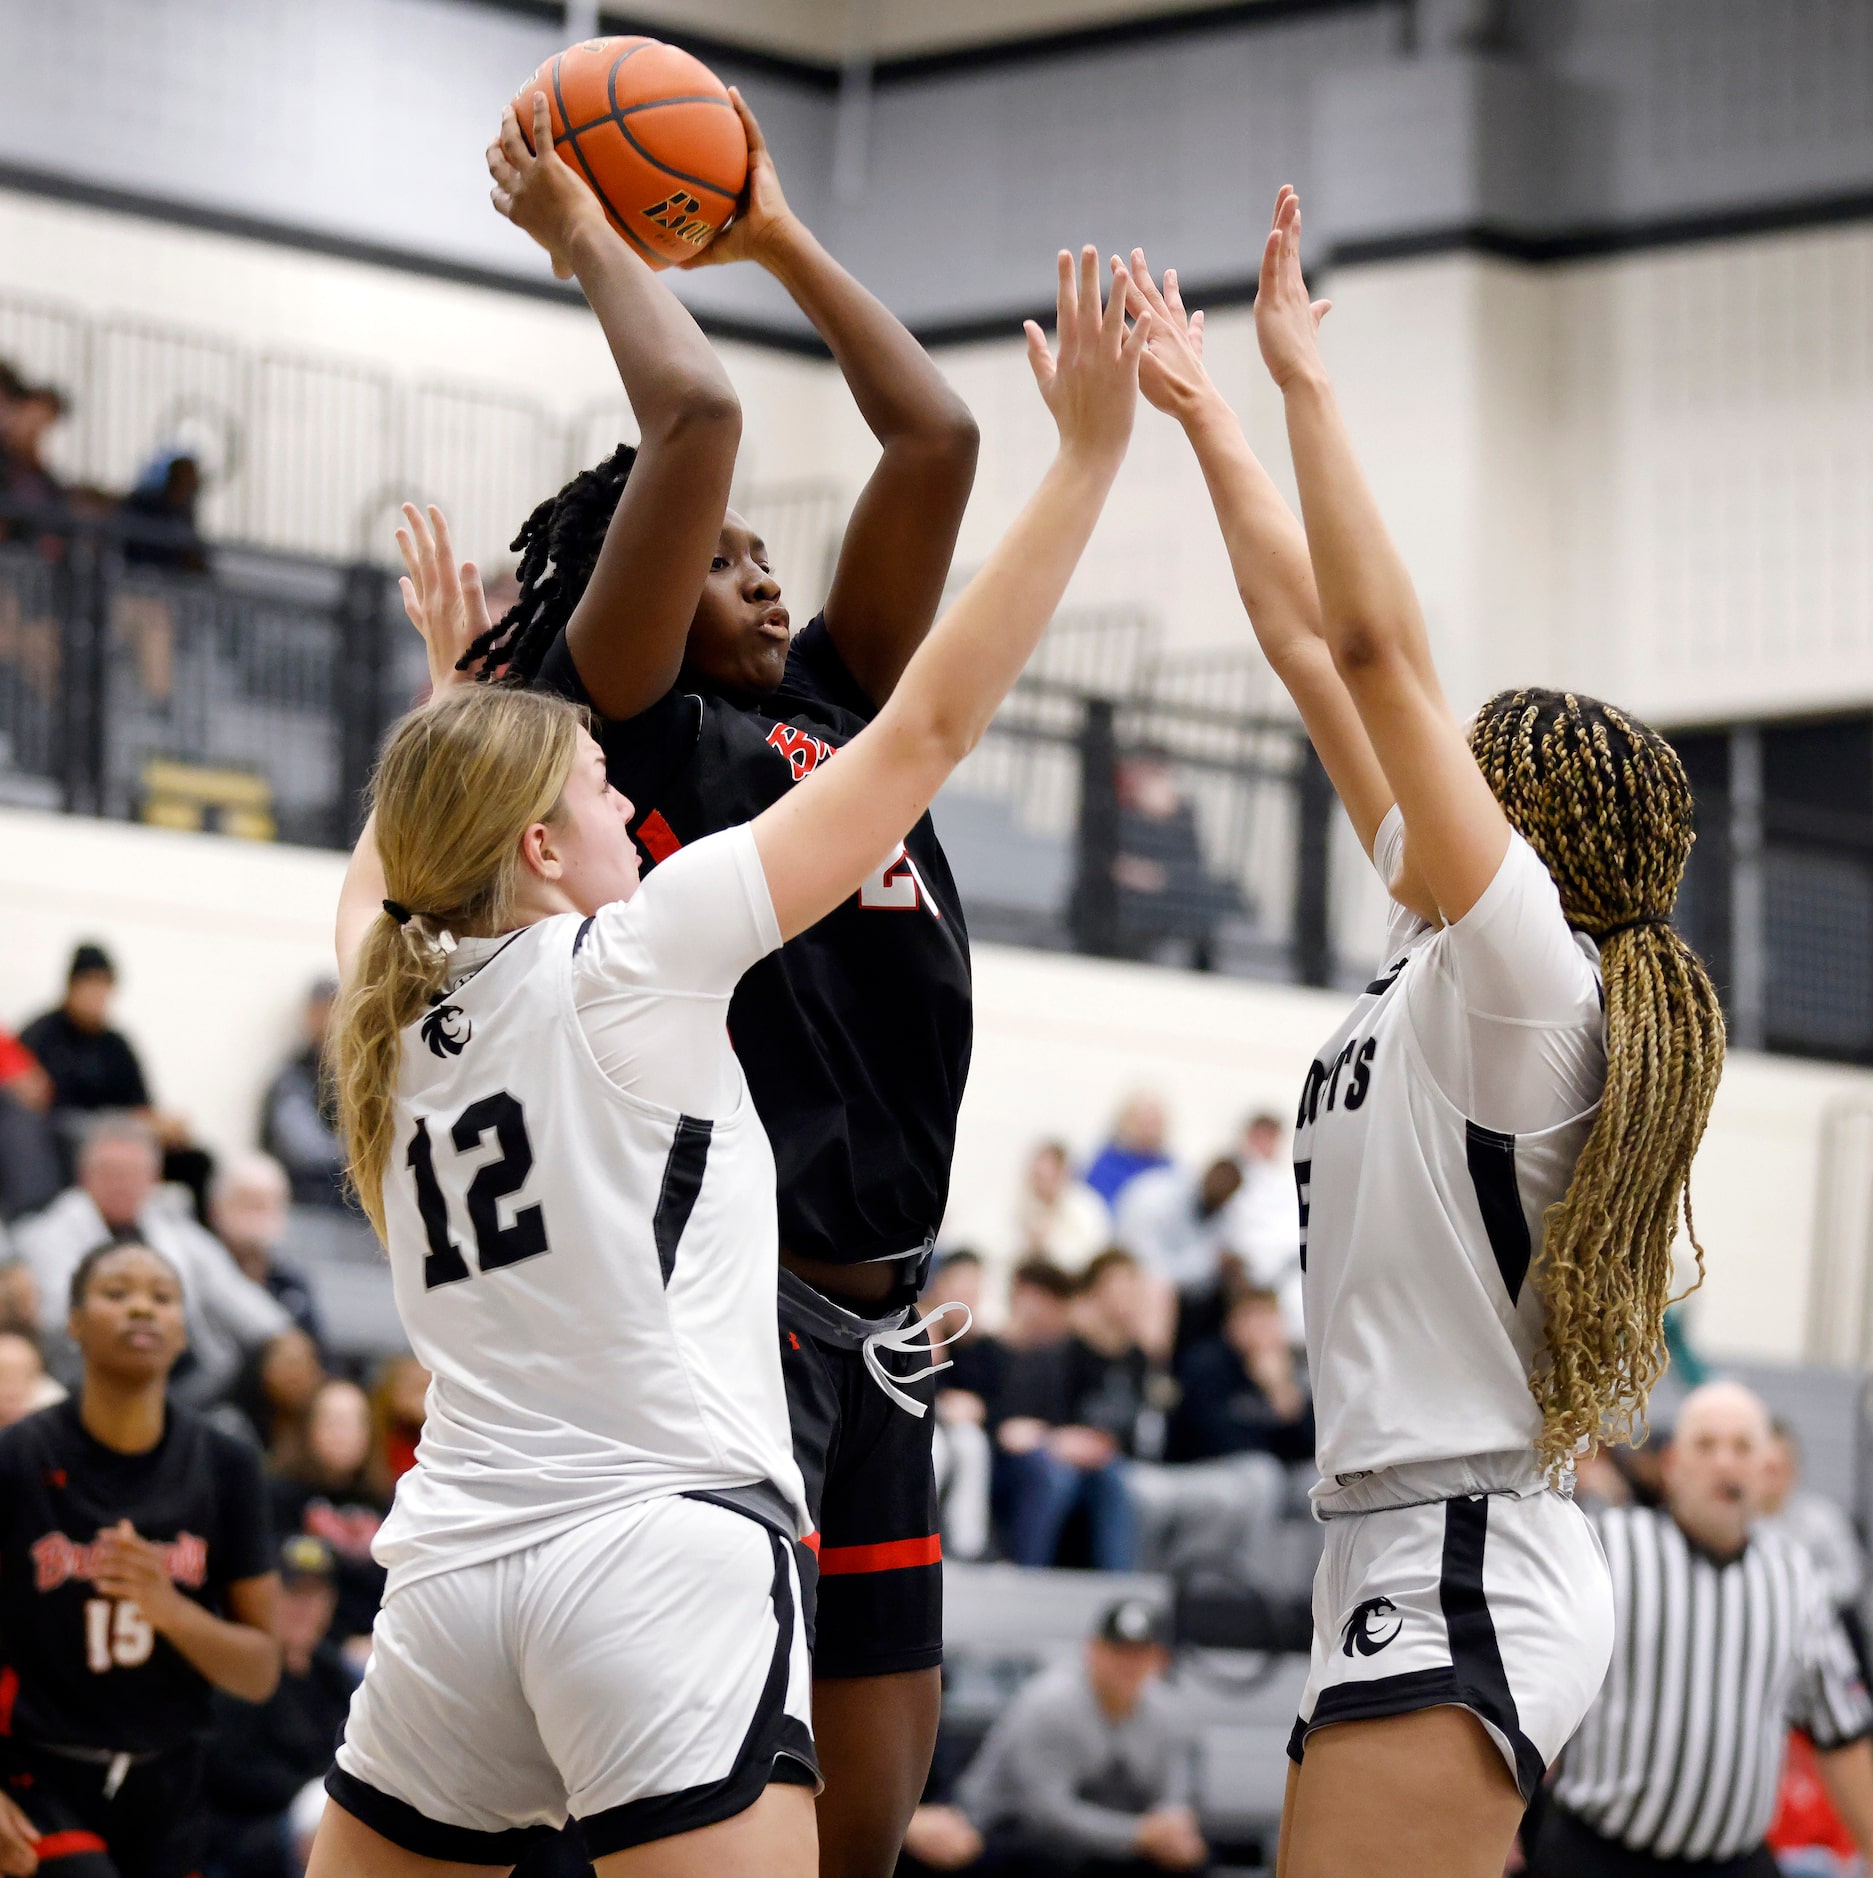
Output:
top-left (1469, 691), bottom-right (1725, 1470)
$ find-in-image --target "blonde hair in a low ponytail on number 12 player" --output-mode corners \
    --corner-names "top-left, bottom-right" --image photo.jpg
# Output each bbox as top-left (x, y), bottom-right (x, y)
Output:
top-left (333, 685), bottom-right (582, 1239)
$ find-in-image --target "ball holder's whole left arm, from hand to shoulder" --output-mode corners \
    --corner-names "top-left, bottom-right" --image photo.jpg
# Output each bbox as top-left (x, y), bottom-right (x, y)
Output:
top-left (488, 92), bottom-right (742, 717)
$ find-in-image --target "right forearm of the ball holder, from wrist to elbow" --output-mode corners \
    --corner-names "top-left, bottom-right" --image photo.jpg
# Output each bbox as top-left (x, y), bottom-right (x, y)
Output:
top-left (761, 216), bottom-right (977, 452)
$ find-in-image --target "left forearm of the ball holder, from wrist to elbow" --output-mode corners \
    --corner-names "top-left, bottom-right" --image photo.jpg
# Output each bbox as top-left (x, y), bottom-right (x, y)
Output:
top-left (567, 223), bottom-right (742, 437)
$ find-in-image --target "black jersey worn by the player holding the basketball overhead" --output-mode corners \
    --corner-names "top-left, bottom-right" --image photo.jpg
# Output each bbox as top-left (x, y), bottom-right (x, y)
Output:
top-left (539, 616), bottom-right (973, 1264)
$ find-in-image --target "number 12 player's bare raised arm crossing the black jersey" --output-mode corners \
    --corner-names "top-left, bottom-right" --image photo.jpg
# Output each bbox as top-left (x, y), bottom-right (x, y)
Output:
top-left (755, 248), bottom-right (1150, 937)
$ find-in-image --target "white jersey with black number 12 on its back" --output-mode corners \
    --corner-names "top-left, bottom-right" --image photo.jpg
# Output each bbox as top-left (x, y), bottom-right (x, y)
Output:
top-left (374, 828), bottom-right (810, 1593)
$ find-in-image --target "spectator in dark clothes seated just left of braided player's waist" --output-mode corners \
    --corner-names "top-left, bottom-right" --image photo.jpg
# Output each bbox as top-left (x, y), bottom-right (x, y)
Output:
top-left (1167, 1285), bottom-right (1313, 1461)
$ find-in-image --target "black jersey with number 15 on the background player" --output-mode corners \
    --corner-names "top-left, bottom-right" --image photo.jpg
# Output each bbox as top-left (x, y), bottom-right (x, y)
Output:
top-left (0, 1401), bottom-right (274, 1754)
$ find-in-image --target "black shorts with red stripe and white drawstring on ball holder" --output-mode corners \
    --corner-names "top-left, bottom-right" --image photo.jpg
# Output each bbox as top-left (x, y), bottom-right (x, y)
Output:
top-left (780, 1270), bottom-right (943, 1679)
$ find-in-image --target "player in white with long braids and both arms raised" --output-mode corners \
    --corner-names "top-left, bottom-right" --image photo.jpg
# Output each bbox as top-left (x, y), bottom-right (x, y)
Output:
top-left (1129, 190), bottom-right (1723, 1878)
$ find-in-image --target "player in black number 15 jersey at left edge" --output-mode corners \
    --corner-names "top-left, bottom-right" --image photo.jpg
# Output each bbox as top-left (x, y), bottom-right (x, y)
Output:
top-left (0, 1245), bottom-right (280, 1878)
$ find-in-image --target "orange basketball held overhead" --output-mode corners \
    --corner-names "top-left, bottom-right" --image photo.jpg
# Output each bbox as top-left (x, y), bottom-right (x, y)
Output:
top-left (513, 38), bottom-right (748, 267)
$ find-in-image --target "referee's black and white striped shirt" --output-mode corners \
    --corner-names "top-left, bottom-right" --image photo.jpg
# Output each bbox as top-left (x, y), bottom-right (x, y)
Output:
top-left (1554, 1508), bottom-right (1873, 1859)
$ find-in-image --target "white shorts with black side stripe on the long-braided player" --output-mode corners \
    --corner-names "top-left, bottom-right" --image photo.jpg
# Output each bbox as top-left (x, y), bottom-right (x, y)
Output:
top-left (1289, 1491), bottom-right (1614, 1799)
